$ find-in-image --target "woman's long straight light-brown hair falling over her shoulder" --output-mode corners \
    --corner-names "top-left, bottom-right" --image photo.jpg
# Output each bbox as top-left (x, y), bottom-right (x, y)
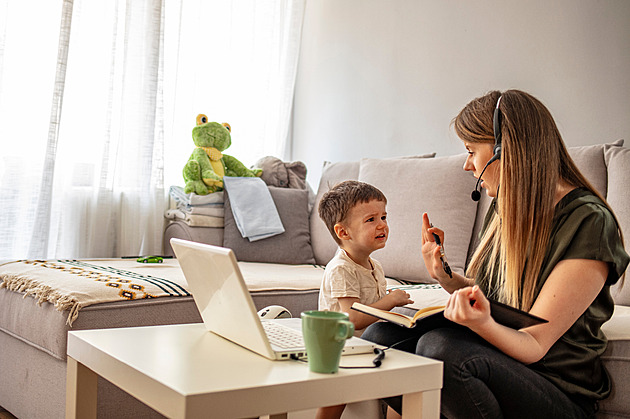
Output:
top-left (453, 90), bottom-right (606, 310)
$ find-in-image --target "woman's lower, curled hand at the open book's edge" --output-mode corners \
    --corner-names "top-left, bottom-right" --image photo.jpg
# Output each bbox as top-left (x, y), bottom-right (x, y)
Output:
top-left (444, 285), bottom-right (492, 330)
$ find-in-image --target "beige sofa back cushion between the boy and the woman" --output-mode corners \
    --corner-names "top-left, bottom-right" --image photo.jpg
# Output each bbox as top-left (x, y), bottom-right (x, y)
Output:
top-left (359, 154), bottom-right (477, 282)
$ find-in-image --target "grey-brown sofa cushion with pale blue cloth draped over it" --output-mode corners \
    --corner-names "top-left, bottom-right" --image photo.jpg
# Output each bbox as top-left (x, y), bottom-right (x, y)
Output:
top-left (223, 186), bottom-right (315, 265)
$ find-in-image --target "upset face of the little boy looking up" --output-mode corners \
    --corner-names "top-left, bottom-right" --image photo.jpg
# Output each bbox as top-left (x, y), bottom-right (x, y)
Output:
top-left (342, 199), bottom-right (389, 255)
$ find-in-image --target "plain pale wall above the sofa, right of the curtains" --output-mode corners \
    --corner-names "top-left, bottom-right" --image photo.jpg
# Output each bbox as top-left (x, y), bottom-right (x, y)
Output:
top-left (291, 0), bottom-right (630, 188)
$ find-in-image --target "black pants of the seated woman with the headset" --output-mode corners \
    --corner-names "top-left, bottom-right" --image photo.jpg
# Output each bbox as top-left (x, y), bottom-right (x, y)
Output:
top-left (361, 322), bottom-right (594, 419)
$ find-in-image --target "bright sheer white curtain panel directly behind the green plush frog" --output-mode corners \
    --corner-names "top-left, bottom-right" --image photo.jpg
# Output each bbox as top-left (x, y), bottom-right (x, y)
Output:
top-left (160, 0), bottom-right (305, 185)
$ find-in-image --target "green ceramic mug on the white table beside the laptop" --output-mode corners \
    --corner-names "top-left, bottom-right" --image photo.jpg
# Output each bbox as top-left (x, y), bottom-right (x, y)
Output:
top-left (302, 310), bottom-right (354, 374)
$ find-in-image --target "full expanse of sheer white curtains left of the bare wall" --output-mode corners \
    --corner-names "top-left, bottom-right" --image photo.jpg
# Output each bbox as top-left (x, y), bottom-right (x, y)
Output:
top-left (0, 0), bottom-right (304, 259)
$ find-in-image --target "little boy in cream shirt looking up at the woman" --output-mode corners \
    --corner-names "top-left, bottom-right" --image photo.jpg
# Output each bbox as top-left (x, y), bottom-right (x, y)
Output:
top-left (316, 180), bottom-right (413, 418)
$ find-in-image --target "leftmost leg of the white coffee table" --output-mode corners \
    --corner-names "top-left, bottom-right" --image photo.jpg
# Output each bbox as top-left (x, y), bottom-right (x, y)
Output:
top-left (66, 357), bottom-right (97, 419)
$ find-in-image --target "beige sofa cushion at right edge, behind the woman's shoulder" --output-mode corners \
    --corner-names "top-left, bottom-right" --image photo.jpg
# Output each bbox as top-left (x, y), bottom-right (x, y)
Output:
top-left (604, 141), bottom-right (630, 305)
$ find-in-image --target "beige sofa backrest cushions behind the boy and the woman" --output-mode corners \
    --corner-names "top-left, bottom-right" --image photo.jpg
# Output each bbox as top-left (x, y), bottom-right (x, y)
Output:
top-left (310, 140), bottom-right (630, 305)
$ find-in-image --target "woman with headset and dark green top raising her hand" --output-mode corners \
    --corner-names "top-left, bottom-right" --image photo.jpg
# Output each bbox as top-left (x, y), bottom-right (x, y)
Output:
top-left (363, 90), bottom-right (630, 418)
